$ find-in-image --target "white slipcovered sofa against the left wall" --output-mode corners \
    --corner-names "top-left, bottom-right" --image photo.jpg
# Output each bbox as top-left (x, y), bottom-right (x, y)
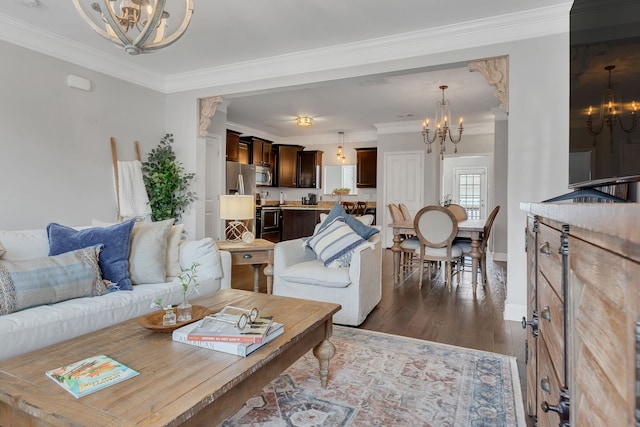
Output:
top-left (0, 226), bottom-right (231, 360)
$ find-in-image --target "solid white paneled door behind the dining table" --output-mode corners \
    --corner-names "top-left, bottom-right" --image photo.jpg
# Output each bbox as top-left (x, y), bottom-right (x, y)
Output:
top-left (377, 151), bottom-right (424, 248)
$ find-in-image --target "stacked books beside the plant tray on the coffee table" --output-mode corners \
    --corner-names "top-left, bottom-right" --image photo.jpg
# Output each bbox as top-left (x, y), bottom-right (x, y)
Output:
top-left (188, 315), bottom-right (273, 344)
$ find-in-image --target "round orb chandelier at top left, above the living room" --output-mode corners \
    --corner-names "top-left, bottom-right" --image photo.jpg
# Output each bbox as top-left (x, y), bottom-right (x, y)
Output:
top-left (73, 0), bottom-right (194, 55)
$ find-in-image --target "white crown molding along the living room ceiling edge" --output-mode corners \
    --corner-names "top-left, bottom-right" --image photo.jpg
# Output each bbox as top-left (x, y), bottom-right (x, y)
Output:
top-left (0, 1), bottom-right (572, 93)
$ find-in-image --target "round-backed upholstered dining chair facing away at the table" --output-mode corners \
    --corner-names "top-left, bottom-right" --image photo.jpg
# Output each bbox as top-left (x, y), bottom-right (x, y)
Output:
top-left (413, 206), bottom-right (462, 291)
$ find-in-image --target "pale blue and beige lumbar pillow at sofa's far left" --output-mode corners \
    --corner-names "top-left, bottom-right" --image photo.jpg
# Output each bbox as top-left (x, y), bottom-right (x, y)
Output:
top-left (0, 245), bottom-right (107, 315)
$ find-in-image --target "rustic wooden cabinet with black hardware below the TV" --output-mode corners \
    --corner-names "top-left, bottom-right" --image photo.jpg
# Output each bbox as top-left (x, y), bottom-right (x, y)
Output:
top-left (521, 203), bottom-right (640, 427)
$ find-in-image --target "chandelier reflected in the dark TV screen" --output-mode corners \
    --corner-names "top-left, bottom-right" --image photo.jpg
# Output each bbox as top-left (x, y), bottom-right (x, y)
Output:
top-left (587, 65), bottom-right (638, 136)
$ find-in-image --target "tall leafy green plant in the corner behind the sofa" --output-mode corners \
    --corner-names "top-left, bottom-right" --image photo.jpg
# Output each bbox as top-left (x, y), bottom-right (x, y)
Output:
top-left (142, 133), bottom-right (196, 221)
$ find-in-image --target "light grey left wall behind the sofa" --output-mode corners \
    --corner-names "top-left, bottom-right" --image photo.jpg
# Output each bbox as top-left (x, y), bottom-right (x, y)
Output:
top-left (0, 41), bottom-right (165, 230)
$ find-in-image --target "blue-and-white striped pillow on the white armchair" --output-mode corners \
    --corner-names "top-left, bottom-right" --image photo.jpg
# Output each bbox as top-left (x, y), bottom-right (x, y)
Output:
top-left (304, 217), bottom-right (367, 267)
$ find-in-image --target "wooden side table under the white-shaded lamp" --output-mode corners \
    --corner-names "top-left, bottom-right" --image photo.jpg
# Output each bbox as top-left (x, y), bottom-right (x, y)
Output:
top-left (216, 239), bottom-right (275, 294)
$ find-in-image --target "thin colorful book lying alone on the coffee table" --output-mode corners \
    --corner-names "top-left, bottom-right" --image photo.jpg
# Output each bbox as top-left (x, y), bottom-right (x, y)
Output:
top-left (46, 354), bottom-right (139, 397)
